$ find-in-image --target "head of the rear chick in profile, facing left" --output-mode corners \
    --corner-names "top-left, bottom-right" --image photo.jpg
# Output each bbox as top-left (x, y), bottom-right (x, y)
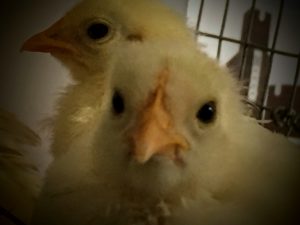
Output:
top-left (22, 0), bottom-right (196, 80)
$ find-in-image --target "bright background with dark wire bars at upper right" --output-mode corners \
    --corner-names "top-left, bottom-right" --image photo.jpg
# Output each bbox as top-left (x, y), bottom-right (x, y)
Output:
top-left (187, 0), bottom-right (300, 144)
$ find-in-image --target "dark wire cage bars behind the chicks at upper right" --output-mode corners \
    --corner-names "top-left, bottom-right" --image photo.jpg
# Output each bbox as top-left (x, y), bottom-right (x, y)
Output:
top-left (195, 0), bottom-right (300, 138)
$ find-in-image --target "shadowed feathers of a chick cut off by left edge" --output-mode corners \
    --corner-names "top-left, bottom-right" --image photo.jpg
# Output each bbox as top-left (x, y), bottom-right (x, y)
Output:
top-left (0, 109), bottom-right (41, 225)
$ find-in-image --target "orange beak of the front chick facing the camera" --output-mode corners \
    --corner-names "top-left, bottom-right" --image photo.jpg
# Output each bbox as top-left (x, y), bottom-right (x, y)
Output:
top-left (132, 70), bottom-right (188, 164)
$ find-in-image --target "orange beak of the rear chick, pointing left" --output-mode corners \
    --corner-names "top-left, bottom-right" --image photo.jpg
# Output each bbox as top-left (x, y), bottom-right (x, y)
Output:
top-left (21, 19), bottom-right (77, 54)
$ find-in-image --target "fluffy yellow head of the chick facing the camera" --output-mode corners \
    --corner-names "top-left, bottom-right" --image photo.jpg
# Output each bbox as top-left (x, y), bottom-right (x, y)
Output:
top-left (85, 43), bottom-right (243, 198)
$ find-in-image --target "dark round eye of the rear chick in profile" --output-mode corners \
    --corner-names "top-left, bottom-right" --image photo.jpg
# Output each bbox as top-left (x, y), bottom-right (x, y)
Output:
top-left (86, 22), bottom-right (111, 41)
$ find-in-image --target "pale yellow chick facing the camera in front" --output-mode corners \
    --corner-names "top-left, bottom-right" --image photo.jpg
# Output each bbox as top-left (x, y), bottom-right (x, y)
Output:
top-left (33, 42), bottom-right (300, 225)
